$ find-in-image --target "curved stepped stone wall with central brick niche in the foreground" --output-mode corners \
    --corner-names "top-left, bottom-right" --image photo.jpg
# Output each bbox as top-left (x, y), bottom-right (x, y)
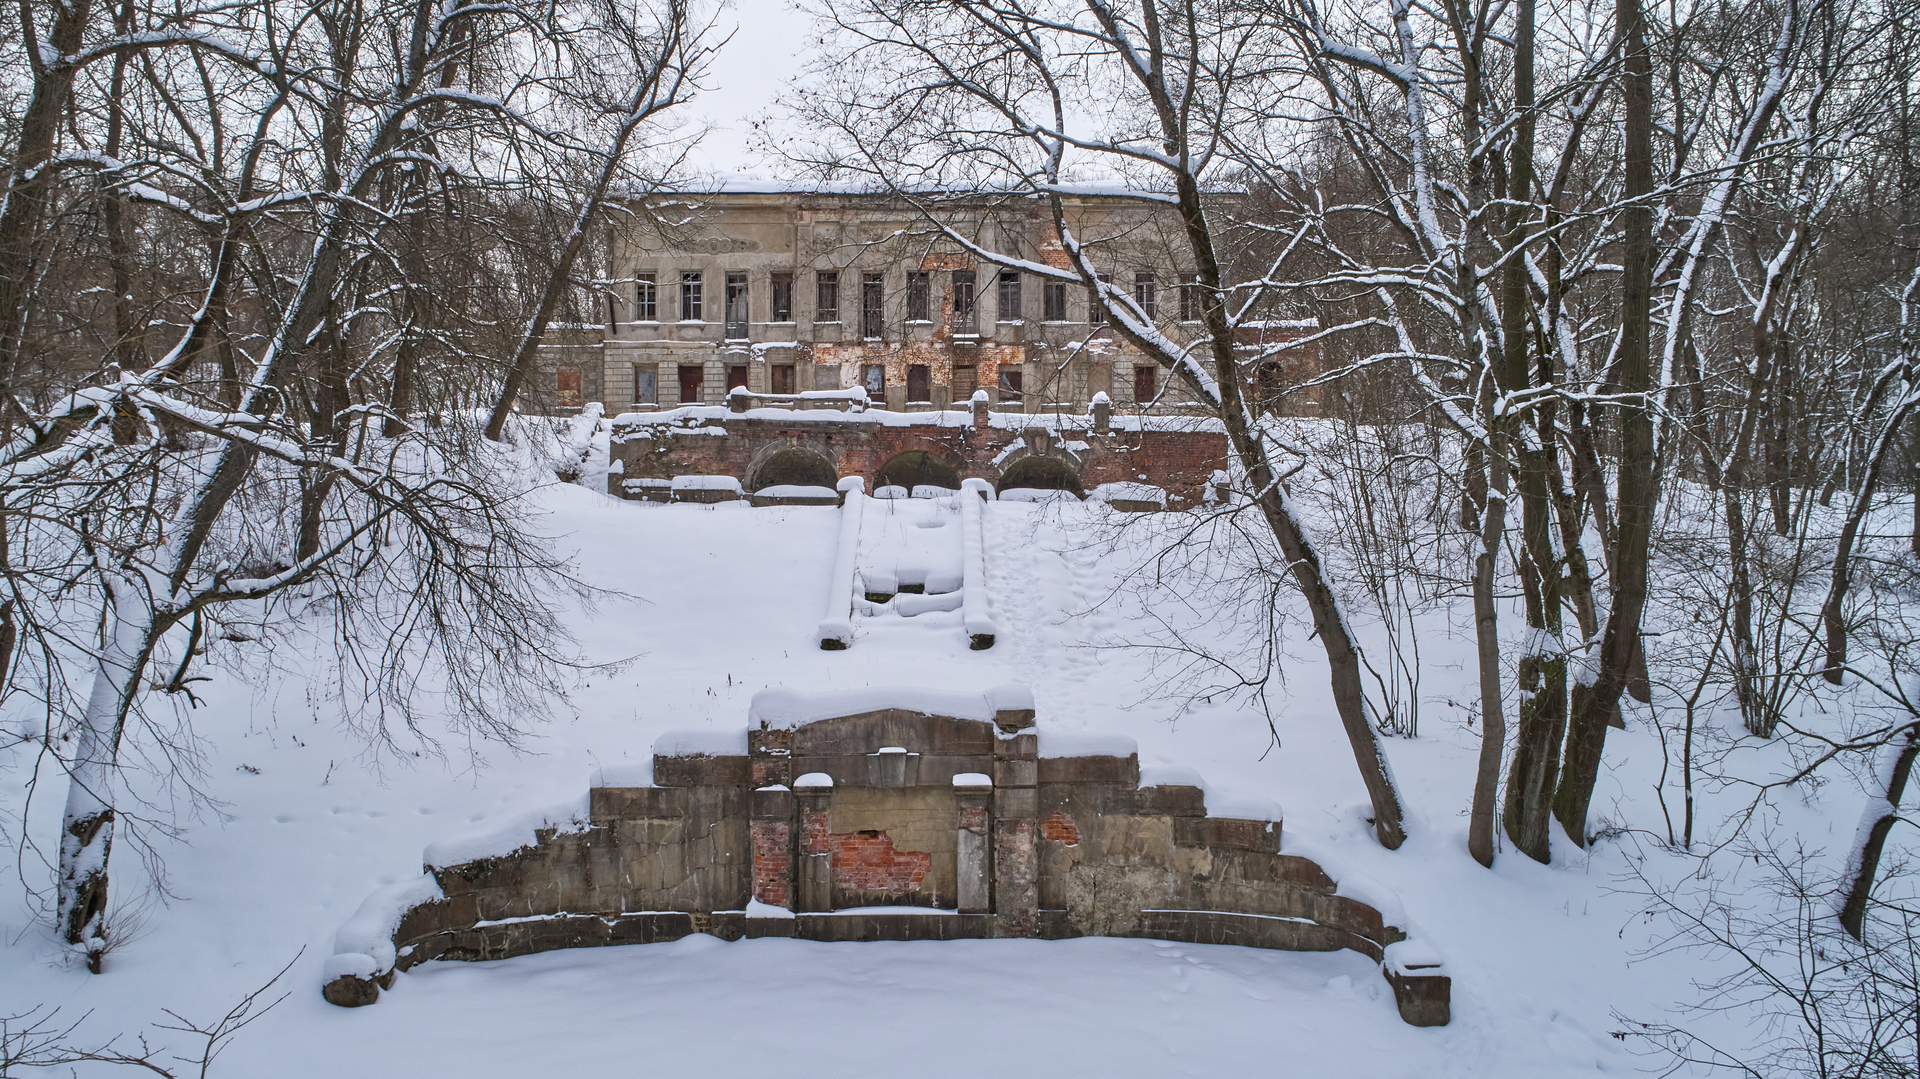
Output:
top-left (326, 708), bottom-right (1450, 1025)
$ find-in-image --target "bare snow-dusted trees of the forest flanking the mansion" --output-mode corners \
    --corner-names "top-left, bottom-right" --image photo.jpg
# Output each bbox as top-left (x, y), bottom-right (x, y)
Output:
top-left (0, 0), bottom-right (1920, 1073)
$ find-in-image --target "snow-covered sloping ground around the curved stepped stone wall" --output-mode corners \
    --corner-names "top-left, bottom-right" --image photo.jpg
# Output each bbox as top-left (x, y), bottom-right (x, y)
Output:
top-left (0, 424), bottom-right (1857, 1077)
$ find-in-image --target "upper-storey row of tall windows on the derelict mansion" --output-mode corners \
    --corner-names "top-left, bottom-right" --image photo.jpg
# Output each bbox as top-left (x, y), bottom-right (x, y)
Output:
top-left (634, 271), bottom-right (1200, 330)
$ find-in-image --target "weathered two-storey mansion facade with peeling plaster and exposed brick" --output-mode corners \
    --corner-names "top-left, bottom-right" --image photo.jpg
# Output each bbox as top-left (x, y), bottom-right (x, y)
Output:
top-left (545, 190), bottom-right (1317, 415)
